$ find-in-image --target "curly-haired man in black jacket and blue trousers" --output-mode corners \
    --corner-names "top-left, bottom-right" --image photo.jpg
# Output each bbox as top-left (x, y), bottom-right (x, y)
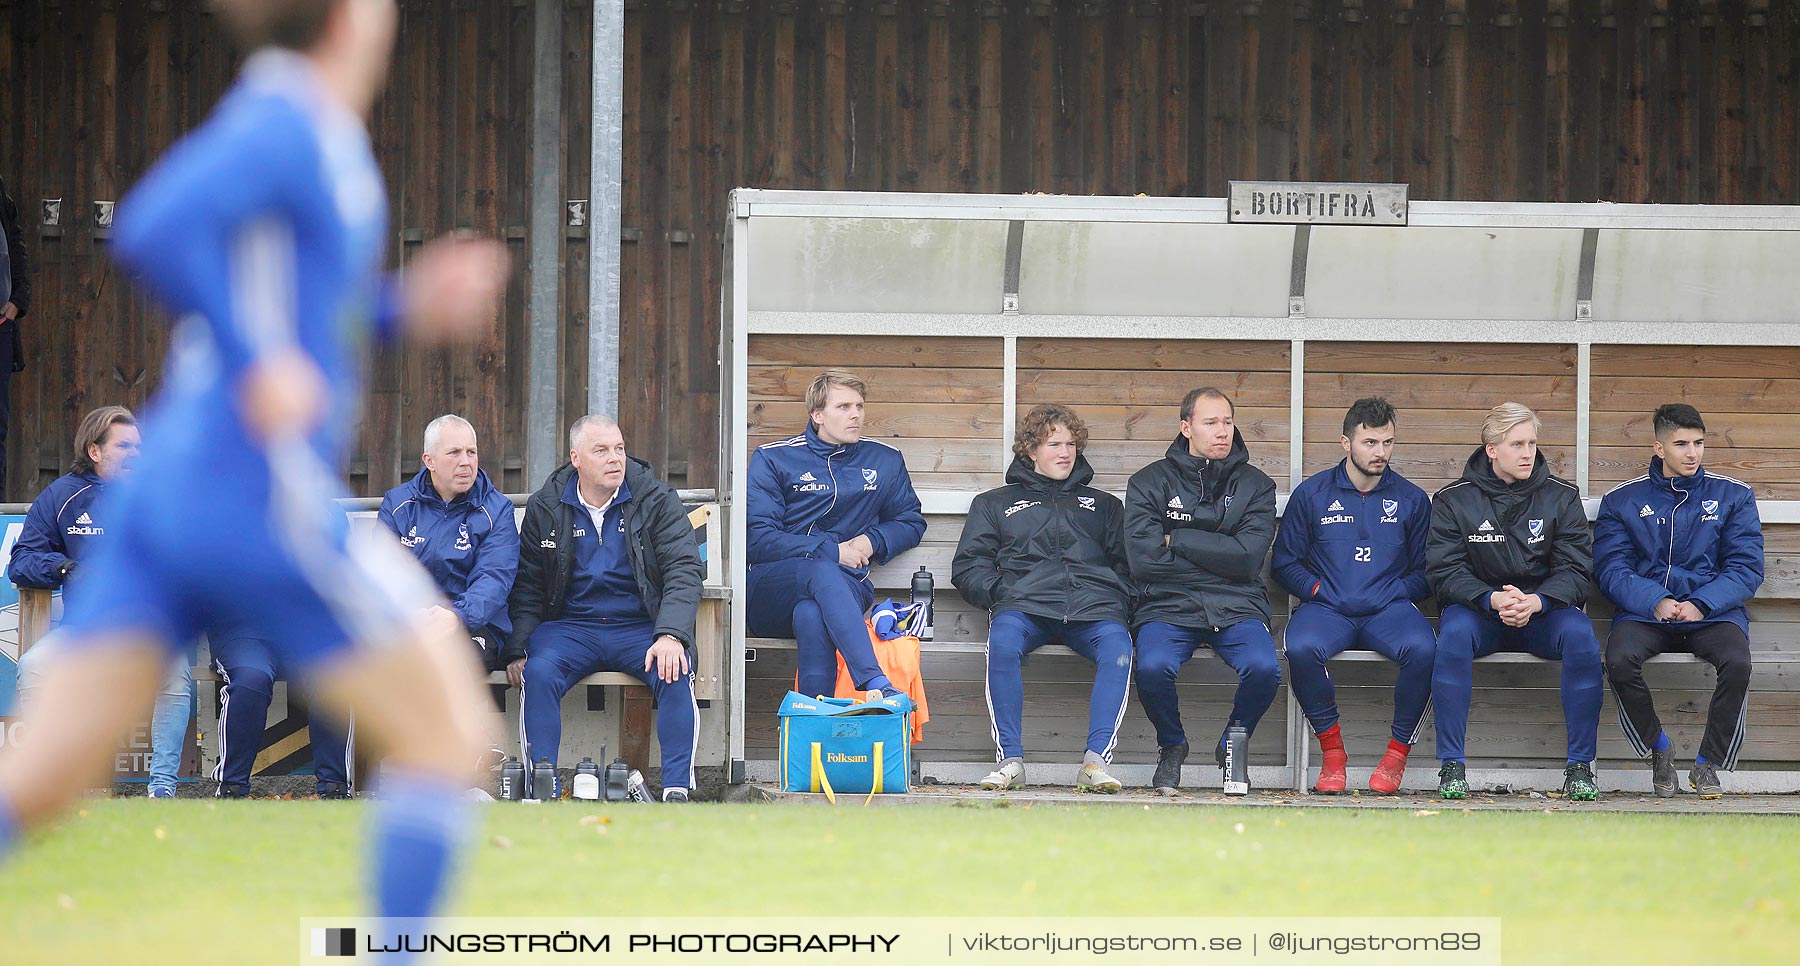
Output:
top-left (950, 405), bottom-right (1132, 793)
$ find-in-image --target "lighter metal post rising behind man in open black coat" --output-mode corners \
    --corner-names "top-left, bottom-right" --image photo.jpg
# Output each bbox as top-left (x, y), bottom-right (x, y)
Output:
top-left (587, 0), bottom-right (626, 416)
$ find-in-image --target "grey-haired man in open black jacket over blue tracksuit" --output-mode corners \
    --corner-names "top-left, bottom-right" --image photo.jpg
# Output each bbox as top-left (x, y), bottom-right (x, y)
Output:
top-left (506, 416), bottom-right (706, 802)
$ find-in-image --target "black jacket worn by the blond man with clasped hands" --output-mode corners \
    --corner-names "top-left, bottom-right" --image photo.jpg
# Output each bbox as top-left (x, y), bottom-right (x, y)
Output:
top-left (1426, 448), bottom-right (1593, 613)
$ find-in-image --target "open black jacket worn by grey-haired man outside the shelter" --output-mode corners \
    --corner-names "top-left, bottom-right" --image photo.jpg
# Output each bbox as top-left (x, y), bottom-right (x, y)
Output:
top-left (500, 459), bottom-right (706, 664)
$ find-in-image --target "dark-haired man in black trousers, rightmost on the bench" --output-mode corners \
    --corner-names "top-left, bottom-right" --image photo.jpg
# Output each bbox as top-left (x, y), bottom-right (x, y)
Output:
top-left (1593, 403), bottom-right (1762, 799)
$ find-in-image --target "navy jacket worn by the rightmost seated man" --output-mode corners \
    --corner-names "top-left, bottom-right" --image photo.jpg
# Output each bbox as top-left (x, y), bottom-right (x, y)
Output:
top-left (1593, 457), bottom-right (1762, 635)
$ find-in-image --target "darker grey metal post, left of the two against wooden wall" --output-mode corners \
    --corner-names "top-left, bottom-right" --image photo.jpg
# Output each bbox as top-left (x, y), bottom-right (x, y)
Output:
top-left (522, 0), bottom-right (563, 489)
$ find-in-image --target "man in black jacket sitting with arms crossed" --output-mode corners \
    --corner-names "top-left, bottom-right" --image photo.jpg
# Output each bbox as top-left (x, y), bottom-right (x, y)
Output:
top-left (1125, 387), bottom-right (1282, 795)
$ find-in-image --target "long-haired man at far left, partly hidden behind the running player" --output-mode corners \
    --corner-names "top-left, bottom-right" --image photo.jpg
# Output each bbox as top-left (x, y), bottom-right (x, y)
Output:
top-left (7, 407), bottom-right (194, 799)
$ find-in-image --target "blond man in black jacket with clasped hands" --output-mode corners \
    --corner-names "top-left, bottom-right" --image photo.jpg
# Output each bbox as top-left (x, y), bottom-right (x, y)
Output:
top-left (1426, 403), bottom-right (1604, 802)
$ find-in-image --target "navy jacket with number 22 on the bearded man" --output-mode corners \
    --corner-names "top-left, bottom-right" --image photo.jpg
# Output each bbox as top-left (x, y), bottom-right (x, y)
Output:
top-left (1271, 461), bottom-right (1431, 617)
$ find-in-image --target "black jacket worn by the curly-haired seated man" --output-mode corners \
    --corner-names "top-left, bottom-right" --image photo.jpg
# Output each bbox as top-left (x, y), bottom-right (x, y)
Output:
top-left (950, 457), bottom-right (1132, 622)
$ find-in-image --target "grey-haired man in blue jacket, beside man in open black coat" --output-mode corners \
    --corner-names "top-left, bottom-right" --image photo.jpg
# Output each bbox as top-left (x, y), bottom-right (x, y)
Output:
top-left (376, 414), bottom-right (518, 671)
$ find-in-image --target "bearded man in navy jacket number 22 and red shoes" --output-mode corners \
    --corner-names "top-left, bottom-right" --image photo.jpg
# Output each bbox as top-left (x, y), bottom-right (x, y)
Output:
top-left (1273, 398), bottom-right (1435, 795)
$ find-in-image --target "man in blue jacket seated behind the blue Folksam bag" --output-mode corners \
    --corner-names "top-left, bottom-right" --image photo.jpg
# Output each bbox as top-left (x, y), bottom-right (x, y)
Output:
top-left (745, 369), bottom-right (925, 694)
